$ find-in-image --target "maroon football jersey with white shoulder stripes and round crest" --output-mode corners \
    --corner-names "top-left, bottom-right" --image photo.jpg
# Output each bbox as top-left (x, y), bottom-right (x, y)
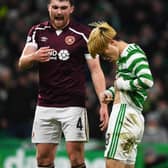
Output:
top-left (26, 21), bottom-right (90, 107)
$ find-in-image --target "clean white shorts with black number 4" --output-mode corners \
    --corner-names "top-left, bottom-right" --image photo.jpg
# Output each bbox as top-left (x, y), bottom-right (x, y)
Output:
top-left (32, 106), bottom-right (89, 144)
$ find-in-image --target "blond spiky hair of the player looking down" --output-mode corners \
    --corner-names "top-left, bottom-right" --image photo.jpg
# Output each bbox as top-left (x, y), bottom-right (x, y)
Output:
top-left (87, 22), bottom-right (117, 58)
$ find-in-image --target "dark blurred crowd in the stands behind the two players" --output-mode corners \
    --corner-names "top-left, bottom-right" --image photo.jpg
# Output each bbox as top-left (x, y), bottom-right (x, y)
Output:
top-left (0, 0), bottom-right (168, 148)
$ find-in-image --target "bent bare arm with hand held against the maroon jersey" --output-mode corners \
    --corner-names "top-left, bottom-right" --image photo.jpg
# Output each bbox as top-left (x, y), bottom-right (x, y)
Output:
top-left (18, 45), bottom-right (52, 70)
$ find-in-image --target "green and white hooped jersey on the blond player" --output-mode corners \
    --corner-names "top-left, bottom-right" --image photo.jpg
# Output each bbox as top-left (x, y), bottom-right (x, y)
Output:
top-left (108, 44), bottom-right (153, 110)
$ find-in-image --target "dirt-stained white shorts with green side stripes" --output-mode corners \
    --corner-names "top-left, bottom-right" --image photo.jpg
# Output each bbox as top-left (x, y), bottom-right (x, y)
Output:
top-left (104, 104), bottom-right (144, 165)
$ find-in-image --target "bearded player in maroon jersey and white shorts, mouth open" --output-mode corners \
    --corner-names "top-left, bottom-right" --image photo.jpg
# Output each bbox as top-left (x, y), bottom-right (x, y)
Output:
top-left (19, 0), bottom-right (108, 168)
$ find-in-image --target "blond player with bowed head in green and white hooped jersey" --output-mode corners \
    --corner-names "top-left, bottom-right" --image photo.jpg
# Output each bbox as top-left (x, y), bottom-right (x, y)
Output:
top-left (88, 22), bottom-right (153, 168)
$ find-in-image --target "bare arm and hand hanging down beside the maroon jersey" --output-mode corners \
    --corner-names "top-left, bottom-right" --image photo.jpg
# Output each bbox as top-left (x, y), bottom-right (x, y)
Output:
top-left (87, 57), bottom-right (108, 131)
